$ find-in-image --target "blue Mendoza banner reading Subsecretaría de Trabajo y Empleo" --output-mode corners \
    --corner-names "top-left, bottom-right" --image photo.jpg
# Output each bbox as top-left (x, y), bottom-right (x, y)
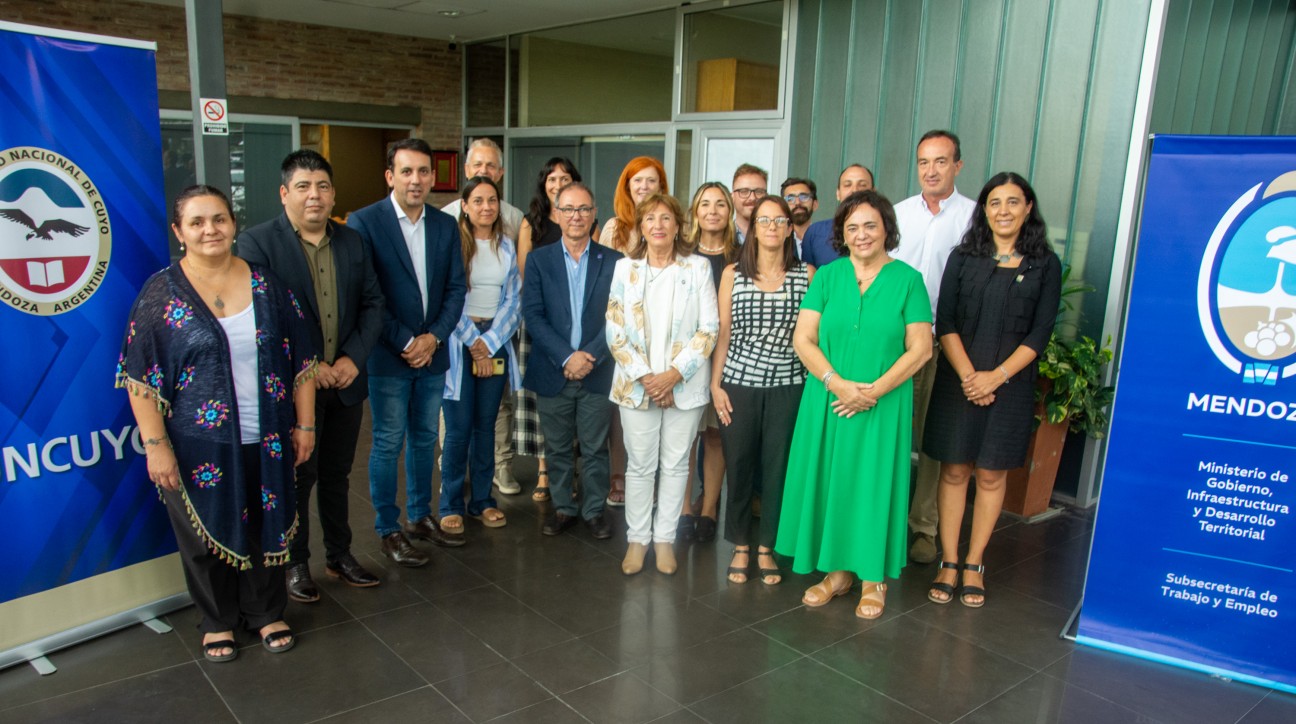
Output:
top-left (1078, 136), bottom-right (1296, 692)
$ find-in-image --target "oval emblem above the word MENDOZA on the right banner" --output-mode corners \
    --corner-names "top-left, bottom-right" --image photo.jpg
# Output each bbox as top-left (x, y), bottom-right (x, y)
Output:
top-left (1198, 171), bottom-right (1296, 386)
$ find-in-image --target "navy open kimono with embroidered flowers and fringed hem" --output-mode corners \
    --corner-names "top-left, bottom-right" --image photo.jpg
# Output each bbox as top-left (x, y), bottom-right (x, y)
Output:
top-left (117, 264), bottom-right (318, 570)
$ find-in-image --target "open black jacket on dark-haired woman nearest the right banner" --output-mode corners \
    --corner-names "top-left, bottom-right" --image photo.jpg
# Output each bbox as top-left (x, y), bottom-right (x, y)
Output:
top-left (936, 249), bottom-right (1061, 360)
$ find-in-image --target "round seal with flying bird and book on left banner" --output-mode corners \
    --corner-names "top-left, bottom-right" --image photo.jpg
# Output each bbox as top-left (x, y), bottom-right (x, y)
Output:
top-left (0, 146), bottom-right (113, 316)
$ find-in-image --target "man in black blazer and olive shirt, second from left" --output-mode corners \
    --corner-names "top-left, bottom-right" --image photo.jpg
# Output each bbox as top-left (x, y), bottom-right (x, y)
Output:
top-left (238, 150), bottom-right (382, 604)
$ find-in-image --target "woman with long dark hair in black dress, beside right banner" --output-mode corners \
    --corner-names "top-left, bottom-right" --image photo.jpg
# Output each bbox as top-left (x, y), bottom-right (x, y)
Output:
top-left (923, 172), bottom-right (1061, 609)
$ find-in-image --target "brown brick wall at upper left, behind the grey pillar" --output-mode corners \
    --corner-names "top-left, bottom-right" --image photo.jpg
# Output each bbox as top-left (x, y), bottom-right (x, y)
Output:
top-left (0, 0), bottom-right (463, 149)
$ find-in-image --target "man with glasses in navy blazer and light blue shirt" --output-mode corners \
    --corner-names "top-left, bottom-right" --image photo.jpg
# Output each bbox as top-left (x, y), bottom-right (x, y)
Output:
top-left (522, 183), bottom-right (621, 540)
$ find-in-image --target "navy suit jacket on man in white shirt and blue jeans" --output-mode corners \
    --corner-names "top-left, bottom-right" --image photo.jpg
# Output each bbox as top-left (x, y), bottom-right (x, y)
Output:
top-left (346, 194), bottom-right (468, 377)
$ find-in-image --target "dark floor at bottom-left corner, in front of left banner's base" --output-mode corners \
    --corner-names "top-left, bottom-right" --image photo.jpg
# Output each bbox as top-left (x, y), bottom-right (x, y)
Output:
top-left (0, 662), bottom-right (236, 724)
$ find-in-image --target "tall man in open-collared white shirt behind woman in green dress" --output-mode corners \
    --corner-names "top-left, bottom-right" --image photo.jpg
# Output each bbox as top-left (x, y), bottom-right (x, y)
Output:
top-left (892, 131), bottom-right (976, 563)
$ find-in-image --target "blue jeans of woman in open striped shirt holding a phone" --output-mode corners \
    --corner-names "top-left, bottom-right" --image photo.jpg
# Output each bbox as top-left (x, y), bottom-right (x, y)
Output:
top-left (441, 347), bottom-right (508, 517)
